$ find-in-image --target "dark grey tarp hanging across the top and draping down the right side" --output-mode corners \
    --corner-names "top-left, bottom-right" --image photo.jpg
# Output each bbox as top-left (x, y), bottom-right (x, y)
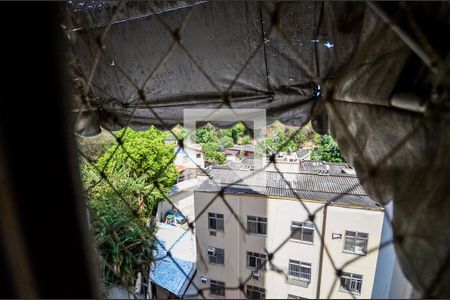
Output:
top-left (68, 1), bottom-right (450, 297)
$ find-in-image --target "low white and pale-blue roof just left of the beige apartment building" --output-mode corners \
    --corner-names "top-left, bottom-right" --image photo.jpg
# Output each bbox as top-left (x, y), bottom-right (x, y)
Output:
top-left (150, 223), bottom-right (196, 297)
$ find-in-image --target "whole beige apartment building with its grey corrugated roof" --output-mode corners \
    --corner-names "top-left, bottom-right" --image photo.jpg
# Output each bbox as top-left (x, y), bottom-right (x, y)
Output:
top-left (194, 167), bottom-right (386, 299)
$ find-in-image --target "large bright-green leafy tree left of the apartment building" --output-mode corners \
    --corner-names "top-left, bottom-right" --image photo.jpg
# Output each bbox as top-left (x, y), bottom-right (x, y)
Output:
top-left (81, 127), bottom-right (178, 290)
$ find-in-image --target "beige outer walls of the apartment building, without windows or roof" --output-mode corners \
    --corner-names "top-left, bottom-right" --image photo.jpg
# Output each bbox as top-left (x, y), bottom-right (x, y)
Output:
top-left (194, 192), bottom-right (383, 298)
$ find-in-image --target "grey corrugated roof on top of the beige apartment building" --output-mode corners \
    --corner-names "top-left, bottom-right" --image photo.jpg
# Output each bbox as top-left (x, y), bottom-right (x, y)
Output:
top-left (197, 168), bottom-right (381, 208)
